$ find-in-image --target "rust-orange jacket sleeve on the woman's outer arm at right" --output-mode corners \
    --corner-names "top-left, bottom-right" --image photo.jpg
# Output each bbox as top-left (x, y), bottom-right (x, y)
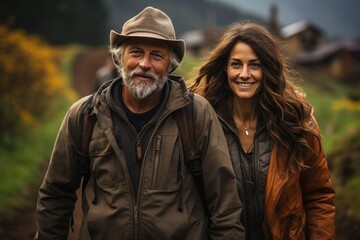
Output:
top-left (301, 115), bottom-right (335, 239)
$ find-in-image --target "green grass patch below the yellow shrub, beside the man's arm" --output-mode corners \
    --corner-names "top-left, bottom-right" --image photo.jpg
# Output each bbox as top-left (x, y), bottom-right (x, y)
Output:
top-left (0, 100), bottom-right (69, 215)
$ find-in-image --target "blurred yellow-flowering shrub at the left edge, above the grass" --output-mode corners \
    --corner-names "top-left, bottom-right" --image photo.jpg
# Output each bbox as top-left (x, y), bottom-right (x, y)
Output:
top-left (0, 25), bottom-right (66, 144)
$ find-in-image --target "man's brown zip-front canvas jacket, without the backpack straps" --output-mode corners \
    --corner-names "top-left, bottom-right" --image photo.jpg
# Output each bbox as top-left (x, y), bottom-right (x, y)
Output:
top-left (36, 80), bottom-right (244, 240)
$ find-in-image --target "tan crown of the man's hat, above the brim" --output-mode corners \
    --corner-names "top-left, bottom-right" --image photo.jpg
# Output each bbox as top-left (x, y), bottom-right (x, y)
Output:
top-left (121, 7), bottom-right (176, 40)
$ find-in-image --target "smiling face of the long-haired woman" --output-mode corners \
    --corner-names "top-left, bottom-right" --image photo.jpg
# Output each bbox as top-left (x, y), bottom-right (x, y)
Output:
top-left (226, 42), bottom-right (263, 100)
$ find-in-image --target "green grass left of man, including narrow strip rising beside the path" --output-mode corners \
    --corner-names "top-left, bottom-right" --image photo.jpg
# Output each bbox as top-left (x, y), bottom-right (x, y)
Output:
top-left (0, 46), bottom-right (83, 220)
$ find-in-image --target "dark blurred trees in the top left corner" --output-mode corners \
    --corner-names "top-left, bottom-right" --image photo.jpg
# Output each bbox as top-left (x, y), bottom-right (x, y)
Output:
top-left (0, 0), bottom-right (109, 45)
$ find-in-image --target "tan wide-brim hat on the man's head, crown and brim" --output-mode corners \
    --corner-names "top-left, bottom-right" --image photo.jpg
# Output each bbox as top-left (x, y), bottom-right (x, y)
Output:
top-left (110, 7), bottom-right (185, 69)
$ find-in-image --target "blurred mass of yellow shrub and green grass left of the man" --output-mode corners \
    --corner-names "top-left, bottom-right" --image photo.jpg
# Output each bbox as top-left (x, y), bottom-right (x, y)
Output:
top-left (0, 26), bottom-right (77, 216)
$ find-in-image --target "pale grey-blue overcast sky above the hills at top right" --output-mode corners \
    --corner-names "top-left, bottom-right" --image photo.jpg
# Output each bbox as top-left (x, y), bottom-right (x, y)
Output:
top-left (217, 0), bottom-right (360, 39)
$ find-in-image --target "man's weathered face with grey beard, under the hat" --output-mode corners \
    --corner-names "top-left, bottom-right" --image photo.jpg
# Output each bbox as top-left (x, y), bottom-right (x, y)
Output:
top-left (121, 39), bottom-right (170, 99)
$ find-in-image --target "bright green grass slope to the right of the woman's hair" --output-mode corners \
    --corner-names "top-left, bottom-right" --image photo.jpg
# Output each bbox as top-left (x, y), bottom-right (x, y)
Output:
top-left (301, 69), bottom-right (360, 154)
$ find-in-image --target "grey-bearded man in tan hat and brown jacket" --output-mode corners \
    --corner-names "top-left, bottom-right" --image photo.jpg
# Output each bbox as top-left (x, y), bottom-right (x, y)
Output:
top-left (36, 7), bottom-right (244, 240)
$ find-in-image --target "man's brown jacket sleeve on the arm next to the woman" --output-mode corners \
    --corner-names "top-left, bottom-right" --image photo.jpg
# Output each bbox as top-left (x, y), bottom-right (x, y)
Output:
top-left (194, 95), bottom-right (245, 239)
